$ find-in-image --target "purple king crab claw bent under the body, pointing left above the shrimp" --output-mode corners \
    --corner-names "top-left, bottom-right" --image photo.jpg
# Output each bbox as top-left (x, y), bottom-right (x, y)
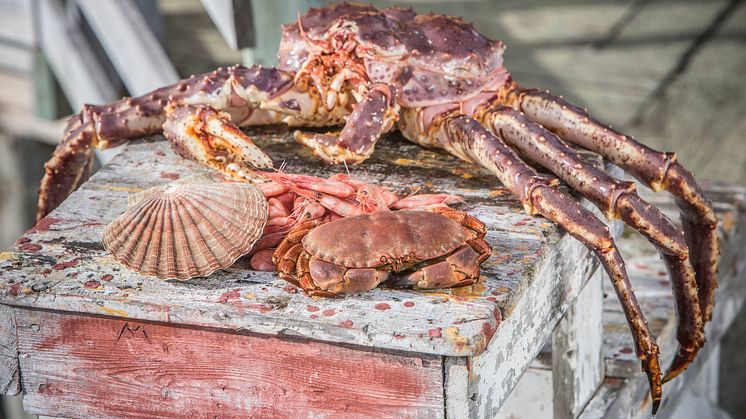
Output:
top-left (295, 83), bottom-right (398, 164)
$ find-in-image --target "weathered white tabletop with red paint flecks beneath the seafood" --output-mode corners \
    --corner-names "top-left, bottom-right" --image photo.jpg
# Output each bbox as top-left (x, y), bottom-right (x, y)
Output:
top-left (0, 129), bottom-right (588, 356)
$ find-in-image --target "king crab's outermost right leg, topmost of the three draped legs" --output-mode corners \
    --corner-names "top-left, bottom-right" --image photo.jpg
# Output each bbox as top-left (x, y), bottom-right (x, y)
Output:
top-left (505, 85), bottom-right (720, 381)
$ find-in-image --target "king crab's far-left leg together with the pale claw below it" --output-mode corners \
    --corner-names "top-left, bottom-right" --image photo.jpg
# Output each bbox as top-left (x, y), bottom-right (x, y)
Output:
top-left (37, 66), bottom-right (338, 219)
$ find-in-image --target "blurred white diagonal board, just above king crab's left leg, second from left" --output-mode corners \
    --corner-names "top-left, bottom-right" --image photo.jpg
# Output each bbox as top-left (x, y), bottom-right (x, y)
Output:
top-left (77, 0), bottom-right (179, 95)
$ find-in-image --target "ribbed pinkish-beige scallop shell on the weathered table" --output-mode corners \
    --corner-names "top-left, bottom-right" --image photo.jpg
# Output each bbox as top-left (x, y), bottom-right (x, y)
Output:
top-left (103, 175), bottom-right (267, 279)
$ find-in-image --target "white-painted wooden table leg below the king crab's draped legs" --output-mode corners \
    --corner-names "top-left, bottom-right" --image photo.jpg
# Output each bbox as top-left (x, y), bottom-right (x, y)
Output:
top-left (552, 269), bottom-right (608, 419)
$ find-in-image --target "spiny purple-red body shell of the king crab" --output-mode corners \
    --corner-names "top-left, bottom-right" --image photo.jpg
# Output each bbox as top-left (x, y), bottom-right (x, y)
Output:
top-left (278, 3), bottom-right (509, 107)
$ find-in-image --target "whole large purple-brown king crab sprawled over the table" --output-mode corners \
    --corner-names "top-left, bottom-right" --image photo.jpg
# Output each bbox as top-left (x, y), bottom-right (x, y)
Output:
top-left (38, 3), bottom-right (719, 411)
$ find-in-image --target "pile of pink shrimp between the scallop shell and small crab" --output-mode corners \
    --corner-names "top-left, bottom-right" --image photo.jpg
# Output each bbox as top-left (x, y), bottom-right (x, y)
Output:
top-left (248, 171), bottom-right (461, 271)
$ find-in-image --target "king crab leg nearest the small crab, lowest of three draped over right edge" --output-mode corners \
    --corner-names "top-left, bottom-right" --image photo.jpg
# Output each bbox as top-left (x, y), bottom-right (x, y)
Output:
top-left (400, 110), bottom-right (662, 411)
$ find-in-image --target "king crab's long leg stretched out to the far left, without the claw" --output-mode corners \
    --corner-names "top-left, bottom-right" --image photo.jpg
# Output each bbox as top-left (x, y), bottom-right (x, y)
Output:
top-left (37, 66), bottom-right (300, 219)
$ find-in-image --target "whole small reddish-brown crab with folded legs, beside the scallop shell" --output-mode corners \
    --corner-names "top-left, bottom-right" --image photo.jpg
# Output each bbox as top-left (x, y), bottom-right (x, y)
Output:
top-left (272, 208), bottom-right (492, 297)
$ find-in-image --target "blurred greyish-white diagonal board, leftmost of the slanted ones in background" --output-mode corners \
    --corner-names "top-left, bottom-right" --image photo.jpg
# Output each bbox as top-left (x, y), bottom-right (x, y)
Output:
top-left (34, 0), bottom-right (118, 109)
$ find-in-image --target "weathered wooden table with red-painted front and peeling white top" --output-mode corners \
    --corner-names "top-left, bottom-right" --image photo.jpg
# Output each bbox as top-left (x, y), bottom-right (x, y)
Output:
top-left (0, 130), bottom-right (741, 417)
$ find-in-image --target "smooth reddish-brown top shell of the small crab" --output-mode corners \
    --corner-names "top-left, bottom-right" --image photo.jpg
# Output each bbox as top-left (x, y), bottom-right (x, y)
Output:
top-left (303, 211), bottom-right (466, 268)
